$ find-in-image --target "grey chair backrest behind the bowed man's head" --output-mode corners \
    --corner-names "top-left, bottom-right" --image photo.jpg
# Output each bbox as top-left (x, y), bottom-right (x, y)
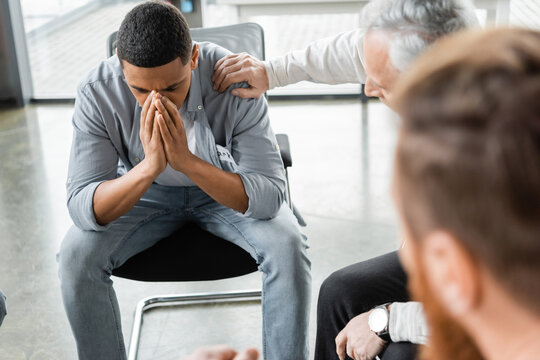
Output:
top-left (107, 23), bottom-right (265, 60)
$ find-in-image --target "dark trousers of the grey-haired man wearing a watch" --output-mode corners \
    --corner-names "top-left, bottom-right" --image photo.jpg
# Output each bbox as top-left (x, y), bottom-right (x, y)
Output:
top-left (315, 251), bottom-right (416, 360)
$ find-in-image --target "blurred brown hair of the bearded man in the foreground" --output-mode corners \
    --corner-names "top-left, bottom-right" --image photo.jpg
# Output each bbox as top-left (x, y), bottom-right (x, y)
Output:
top-left (396, 29), bottom-right (540, 314)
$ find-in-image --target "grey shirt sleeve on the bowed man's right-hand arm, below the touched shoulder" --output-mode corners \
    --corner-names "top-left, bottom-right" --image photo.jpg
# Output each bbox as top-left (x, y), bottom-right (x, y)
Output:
top-left (231, 91), bottom-right (286, 219)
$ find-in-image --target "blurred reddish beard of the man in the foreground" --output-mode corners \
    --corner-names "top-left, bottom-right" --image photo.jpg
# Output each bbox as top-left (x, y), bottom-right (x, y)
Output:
top-left (409, 262), bottom-right (484, 360)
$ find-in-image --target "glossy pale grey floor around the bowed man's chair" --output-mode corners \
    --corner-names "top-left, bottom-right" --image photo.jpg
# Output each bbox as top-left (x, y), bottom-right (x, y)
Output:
top-left (0, 100), bottom-right (398, 360)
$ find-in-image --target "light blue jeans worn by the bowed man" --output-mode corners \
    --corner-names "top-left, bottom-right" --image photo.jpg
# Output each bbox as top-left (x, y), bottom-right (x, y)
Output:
top-left (58, 185), bottom-right (311, 360)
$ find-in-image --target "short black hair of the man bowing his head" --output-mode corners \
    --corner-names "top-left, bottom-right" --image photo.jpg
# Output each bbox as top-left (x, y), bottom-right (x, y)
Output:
top-left (116, 0), bottom-right (192, 68)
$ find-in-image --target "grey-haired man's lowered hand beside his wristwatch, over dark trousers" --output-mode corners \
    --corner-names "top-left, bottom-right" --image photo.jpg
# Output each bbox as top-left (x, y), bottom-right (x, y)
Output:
top-left (336, 311), bottom-right (386, 360)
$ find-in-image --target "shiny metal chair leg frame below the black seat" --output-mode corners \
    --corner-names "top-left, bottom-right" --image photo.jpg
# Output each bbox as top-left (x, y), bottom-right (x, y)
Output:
top-left (128, 290), bottom-right (262, 360)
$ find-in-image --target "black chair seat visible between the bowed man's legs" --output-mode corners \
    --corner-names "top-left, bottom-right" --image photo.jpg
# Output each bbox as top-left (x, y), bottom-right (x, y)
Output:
top-left (113, 224), bottom-right (258, 281)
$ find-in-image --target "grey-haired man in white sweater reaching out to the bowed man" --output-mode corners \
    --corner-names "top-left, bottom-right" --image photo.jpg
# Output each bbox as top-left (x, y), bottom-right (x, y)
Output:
top-left (213, 0), bottom-right (478, 360)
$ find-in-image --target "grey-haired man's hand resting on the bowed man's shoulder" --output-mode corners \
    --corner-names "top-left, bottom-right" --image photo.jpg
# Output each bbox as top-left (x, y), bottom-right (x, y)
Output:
top-left (212, 53), bottom-right (269, 98)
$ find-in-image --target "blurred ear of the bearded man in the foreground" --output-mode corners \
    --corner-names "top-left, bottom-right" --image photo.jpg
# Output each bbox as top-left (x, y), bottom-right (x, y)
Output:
top-left (420, 231), bottom-right (481, 316)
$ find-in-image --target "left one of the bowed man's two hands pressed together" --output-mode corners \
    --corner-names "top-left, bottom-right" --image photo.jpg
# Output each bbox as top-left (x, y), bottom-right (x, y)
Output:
top-left (139, 91), bottom-right (167, 177)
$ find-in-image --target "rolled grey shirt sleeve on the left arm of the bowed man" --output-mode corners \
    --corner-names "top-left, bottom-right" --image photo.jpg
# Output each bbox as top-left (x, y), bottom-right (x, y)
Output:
top-left (66, 85), bottom-right (118, 231)
